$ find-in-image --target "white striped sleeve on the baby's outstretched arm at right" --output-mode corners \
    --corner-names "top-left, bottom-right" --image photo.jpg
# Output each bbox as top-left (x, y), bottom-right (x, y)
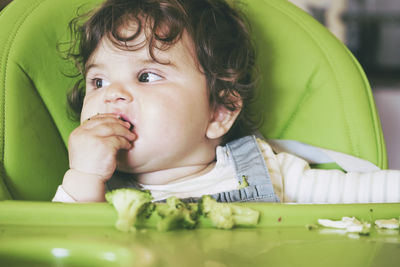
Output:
top-left (276, 153), bottom-right (400, 203)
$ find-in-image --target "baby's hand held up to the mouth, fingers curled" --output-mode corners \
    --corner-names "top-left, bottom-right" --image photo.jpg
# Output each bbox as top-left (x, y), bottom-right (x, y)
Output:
top-left (68, 114), bottom-right (136, 182)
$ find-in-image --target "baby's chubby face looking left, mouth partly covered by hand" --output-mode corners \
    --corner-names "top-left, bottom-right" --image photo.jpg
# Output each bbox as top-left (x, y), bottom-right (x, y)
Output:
top-left (81, 29), bottom-right (216, 177)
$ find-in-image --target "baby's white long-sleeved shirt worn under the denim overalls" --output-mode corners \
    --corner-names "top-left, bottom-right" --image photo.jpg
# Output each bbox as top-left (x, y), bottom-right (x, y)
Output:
top-left (53, 139), bottom-right (400, 203)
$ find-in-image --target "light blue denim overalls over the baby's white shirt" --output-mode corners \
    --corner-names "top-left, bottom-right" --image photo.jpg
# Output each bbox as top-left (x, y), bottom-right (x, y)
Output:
top-left (106, 135), bottom-right (280, 203)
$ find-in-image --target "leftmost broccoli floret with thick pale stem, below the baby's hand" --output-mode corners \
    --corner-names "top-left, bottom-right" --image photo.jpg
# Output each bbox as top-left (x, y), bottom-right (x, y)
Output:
top-left (106, 188), bottom-right (154, 232)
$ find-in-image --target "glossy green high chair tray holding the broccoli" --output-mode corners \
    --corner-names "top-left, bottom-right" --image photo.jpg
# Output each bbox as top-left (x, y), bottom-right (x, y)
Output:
top-left (0, 201), bottom-right (400, 267)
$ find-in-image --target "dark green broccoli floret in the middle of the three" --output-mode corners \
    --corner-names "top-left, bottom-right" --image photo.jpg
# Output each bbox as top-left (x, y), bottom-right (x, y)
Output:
top-left (156, 197), bottom-right (198, 232)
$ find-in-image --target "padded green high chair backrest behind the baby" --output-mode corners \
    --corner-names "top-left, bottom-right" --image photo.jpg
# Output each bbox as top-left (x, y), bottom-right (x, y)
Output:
top-left (0, 0), bottom-right (387, 200)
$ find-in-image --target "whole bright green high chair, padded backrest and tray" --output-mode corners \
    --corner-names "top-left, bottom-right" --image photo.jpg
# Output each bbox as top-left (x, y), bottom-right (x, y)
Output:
top-left (0, 0), bottom-right (400, 266)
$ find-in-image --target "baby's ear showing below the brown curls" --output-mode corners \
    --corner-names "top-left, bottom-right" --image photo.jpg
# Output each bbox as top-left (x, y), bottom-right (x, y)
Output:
top-left (206, 95), bottom-right (243, 139)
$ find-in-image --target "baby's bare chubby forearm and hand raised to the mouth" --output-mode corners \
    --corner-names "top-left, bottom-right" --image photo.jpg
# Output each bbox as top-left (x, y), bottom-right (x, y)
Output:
top-left (53, 114), bottom-right (136, 202)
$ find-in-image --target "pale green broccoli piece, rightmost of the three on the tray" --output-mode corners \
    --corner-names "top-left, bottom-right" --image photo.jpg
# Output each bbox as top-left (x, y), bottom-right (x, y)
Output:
top-left (199, 196), bottom-right (260, 229)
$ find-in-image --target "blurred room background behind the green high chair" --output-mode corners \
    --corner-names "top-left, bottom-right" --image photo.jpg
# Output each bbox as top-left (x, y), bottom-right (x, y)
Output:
top-left (0, 0), bottom-right (400, 169)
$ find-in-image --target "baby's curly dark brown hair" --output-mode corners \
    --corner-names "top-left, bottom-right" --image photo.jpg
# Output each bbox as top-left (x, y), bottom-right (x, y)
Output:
top-left (64, 0), bottom-right (256, 143)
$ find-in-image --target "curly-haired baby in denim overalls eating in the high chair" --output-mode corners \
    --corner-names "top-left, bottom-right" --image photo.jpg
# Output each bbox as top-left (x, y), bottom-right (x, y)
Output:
top-left (53, 0), bottom-right (400, 203)
